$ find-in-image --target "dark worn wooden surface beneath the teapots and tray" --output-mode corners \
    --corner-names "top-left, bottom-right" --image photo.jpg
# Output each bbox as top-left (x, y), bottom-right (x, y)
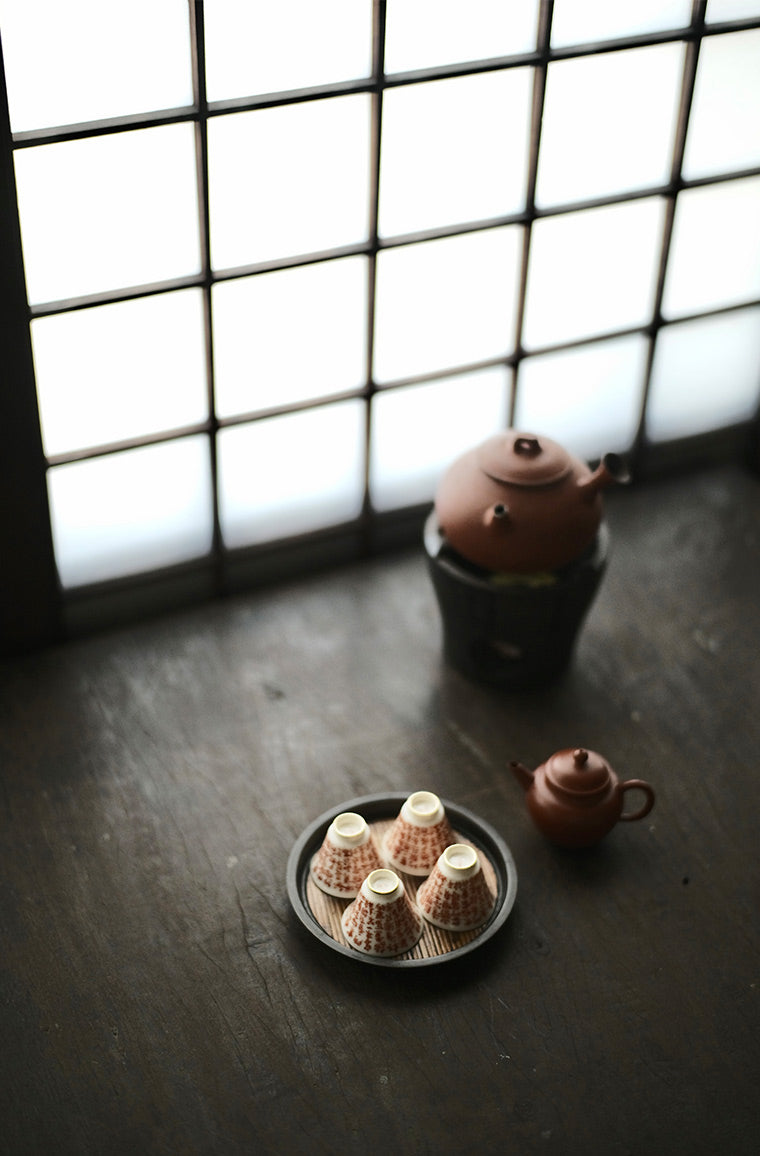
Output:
top-left (0, 467), bottom-right (760, 1156)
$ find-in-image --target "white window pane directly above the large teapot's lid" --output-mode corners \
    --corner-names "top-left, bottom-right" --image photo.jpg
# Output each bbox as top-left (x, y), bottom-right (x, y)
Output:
top-left (515, 335), bottom-right (648, 460)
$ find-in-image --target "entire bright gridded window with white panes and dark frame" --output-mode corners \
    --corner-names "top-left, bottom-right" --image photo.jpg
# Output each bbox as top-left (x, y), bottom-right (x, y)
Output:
top-left (0, 0), bottom-right (760, 640)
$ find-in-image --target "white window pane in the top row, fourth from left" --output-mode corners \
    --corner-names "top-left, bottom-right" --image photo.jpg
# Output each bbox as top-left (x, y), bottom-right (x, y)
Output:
top-left (552, 0), bottom-right (692, 47)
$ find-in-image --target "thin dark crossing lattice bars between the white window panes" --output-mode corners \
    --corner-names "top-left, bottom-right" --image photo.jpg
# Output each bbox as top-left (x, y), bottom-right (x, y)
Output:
top-left (5, 0), bottom-right (760, 593)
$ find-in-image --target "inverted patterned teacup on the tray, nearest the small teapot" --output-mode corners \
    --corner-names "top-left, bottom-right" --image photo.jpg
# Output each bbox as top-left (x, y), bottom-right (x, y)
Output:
top-left (416, 843), bottom-right (495, 932)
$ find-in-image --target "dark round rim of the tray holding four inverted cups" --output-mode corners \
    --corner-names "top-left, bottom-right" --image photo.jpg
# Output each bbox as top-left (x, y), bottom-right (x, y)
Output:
top-left (286, 791), bottom-right (517, 968)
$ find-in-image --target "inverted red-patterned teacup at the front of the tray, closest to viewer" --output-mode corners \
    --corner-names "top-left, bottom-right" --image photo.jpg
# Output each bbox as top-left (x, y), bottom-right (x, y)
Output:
top-left (340, 867), bottom-right (423, 956)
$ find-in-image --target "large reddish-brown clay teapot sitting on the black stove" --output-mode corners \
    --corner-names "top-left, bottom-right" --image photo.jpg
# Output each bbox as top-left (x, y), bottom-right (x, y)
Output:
top-left (435, 430), bottom-right (628, 573)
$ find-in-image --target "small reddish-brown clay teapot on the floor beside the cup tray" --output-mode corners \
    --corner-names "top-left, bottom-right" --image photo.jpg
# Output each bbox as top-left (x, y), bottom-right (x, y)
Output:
top-left (509, 747), bottom-right (655, 847)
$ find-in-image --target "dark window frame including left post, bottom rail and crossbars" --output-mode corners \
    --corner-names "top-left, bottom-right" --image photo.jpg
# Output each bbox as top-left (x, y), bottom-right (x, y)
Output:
top-left (0, 0), bottom-right (760, 653)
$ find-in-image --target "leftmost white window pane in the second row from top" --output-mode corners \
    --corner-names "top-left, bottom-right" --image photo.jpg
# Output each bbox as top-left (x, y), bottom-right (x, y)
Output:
top-left (15, 125), bottom-right (200, 303)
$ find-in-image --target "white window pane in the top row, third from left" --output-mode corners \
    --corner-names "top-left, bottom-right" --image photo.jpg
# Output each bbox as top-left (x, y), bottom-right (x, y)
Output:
top-left (385, 0), bottom-right (538, 73)
